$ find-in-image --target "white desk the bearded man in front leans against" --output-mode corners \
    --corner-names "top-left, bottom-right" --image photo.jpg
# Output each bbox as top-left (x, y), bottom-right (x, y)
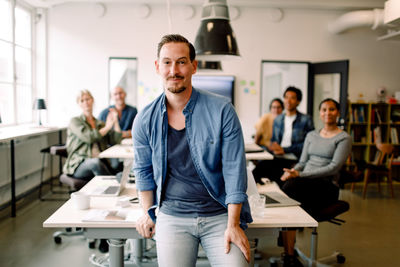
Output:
top-left (43, 177), bottom-right (318, 267)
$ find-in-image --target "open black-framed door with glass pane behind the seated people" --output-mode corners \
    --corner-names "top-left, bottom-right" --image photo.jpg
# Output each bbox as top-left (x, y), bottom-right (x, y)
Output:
top-left (308, 60), bottom-right (349, 129)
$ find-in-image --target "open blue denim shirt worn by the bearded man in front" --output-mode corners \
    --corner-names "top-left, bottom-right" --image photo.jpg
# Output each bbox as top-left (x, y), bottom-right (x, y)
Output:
top-left (132, 88), bottom-right (252, 229)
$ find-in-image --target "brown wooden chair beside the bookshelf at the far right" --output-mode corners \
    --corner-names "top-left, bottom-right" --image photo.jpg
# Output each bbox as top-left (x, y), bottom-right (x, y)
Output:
top-left (363, 143), bottom-right (394, 199)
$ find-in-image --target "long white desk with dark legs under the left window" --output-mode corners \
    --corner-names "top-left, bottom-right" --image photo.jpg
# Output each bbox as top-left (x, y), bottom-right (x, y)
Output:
top-left (0, 125), bottom-right (66, 217)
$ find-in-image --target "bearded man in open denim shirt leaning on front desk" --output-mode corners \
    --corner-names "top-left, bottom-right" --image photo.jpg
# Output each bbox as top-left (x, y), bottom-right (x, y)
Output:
top-left (132, 34), bottom-right (252, 267)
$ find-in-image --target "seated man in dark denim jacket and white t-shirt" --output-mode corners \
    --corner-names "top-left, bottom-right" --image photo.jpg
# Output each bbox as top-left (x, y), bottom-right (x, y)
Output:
top-left (253, 86), bottom-right (314, 186)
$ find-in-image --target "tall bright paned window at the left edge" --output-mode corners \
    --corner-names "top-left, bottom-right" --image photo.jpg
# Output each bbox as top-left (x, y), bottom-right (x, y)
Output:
top-left (0, 0), bottom-right (33, 125)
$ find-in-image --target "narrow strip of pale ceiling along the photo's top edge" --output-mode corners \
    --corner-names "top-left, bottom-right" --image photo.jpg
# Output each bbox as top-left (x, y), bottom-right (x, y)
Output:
top-left (23, 0), bottom-right (386, 10)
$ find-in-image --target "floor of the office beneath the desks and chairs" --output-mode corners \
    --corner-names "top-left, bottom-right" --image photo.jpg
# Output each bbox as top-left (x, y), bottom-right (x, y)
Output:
top-left (0, 183), bottom-right (400, 267)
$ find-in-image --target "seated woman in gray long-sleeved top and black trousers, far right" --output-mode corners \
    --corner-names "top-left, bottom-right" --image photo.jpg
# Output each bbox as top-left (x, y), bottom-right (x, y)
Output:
top-left (281, 98), bottom-right (351, 266)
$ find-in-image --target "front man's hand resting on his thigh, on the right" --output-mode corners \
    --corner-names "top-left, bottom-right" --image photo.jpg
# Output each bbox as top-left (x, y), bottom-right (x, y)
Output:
top-left (225, 225), bottom-right (250, 262)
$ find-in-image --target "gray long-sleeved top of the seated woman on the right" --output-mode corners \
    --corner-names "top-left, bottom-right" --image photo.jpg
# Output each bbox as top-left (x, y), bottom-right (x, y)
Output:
top-left (294, 130), bottom-right (351, 178)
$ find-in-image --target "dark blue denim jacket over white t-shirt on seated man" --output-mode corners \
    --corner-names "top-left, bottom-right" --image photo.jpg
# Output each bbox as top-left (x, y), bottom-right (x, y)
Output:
top-left (271, 111), bottom-right (314, 158)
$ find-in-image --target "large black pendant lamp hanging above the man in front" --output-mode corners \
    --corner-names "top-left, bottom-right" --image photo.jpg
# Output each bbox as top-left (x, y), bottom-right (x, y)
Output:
top-left (194, 0), bottom-right (240, 61)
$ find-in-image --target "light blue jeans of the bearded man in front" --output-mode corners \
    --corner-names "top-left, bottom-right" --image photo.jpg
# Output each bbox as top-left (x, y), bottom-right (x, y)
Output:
top-left (155, 212), bottom-right (248, 267)
